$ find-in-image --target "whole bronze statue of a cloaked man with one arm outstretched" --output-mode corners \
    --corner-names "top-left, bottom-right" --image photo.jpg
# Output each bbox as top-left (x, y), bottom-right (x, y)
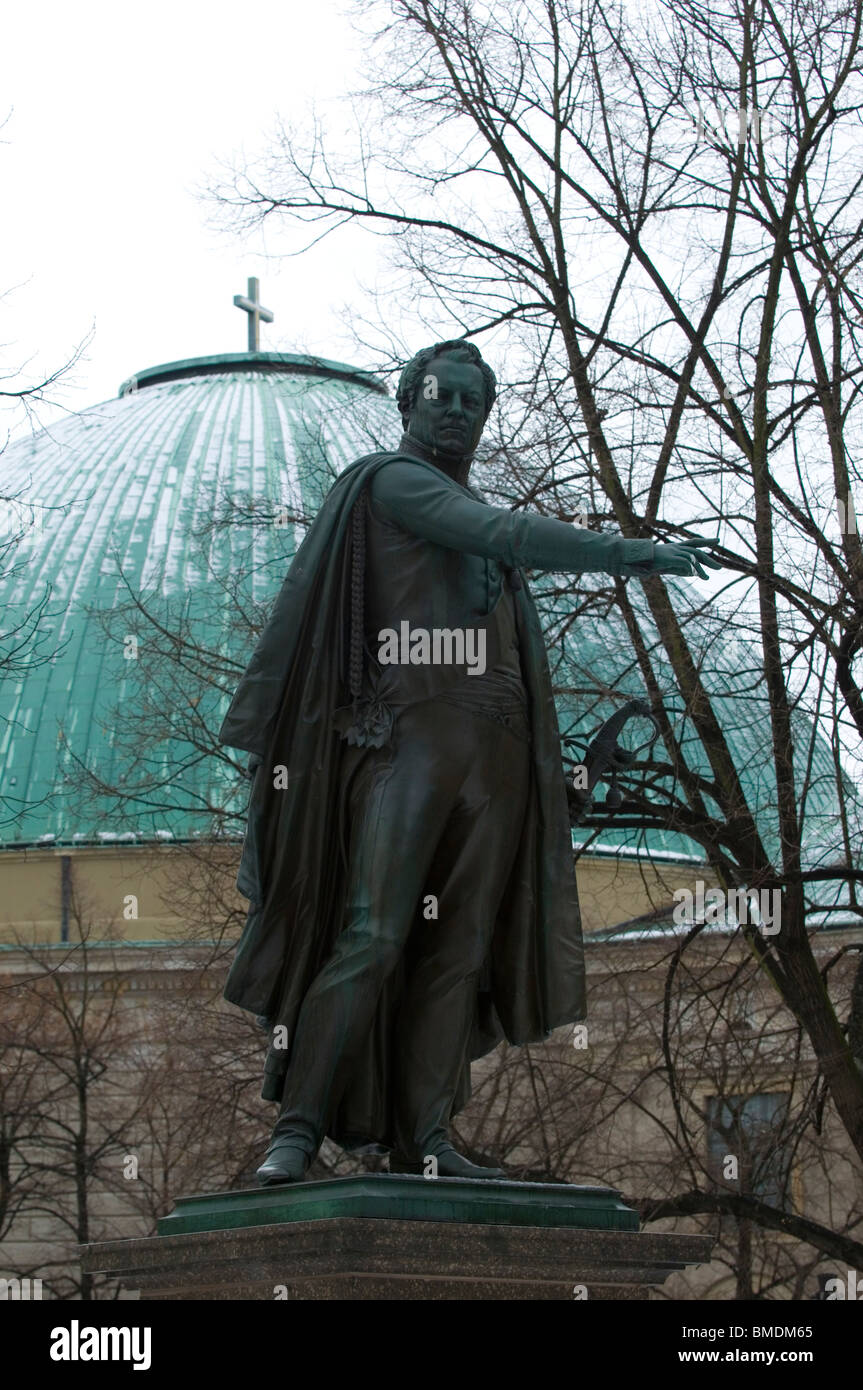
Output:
top-left (220, 341), bottom-right (720, 1183)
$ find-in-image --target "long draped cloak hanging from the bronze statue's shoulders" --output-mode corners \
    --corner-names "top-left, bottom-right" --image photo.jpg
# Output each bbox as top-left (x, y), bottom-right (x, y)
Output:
top-left (220, 453), bottom-right (585, 1143)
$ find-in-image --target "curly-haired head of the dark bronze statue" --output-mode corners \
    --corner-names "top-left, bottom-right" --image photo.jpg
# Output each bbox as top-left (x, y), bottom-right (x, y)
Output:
top-left (396, 338), bottom-right (498, 457)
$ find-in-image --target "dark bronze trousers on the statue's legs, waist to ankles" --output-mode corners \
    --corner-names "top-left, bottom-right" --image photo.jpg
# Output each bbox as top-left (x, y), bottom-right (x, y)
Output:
top-left (274, 701), bottom-right (531, 1159)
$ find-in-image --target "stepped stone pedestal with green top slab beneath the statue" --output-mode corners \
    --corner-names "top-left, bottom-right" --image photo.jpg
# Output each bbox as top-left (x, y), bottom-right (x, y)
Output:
top-left (82, 1173), bottom-right (713, 1300)
